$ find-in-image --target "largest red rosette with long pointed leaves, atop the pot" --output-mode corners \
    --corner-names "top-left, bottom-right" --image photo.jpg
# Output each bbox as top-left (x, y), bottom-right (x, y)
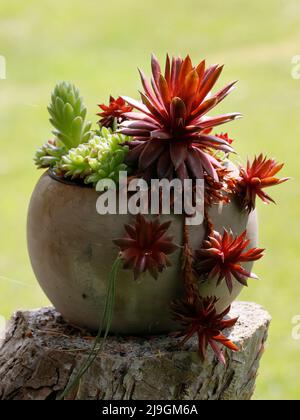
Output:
top-left (121, 56), bottom-right (240, 181)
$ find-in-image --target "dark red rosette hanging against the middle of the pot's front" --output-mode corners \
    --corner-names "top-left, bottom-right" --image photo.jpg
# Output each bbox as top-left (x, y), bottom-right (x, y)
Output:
top-left (114, 215), bottom-right (178, 280)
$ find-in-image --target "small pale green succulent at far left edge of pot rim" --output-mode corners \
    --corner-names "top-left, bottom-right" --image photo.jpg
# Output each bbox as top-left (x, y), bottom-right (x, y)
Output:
top-left (34, 140), bottom-right (66, 168)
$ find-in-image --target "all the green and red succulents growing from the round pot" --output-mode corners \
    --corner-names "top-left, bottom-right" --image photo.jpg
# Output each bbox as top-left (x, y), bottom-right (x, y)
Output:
top-left (35, 56), bottom-right (288, 370)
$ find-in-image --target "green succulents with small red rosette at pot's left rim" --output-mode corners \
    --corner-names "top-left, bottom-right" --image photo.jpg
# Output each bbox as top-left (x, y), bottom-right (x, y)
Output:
top-left (34, 82), bottom-right (131, 185)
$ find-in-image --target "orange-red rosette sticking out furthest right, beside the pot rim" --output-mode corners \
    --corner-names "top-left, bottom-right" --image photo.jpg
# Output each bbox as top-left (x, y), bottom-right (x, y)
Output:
top-left (236, 154), bottom-right (290, 212)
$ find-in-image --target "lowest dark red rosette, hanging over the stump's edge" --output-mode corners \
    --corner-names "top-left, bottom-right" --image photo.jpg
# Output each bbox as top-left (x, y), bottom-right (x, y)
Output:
top-left (171, 297), bottom-right (239, 364)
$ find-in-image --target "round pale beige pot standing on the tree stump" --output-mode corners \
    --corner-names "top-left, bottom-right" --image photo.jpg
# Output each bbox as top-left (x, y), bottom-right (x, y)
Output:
top-left (28, 174), bottom-right (257, 334)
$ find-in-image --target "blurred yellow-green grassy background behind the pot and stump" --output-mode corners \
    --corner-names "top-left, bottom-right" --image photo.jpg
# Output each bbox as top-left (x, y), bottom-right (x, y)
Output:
top-left (0, 0), bottom-right (300, 399)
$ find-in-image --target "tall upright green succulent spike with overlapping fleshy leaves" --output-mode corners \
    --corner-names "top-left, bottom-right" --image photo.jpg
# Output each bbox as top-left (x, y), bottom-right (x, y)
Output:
top-left (48, 82), bottom-right (91, 150)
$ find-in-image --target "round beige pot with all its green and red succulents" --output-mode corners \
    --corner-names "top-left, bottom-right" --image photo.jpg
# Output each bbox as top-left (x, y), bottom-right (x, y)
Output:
top-left (28, 56), bottom-right (287, 362)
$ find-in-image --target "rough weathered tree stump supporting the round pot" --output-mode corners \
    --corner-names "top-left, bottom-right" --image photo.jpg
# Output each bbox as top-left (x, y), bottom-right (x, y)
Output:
top-left (0, 302), bottom-right (270, 400)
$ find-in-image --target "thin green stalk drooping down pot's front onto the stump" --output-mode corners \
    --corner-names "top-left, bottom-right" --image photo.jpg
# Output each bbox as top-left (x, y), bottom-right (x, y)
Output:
top-left (57, 257), bottom-right (123, 400)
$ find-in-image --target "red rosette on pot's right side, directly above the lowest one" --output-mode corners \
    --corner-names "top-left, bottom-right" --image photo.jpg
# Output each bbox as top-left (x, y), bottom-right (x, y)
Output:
top-left (195, 230), bottom-right (264, 293)
